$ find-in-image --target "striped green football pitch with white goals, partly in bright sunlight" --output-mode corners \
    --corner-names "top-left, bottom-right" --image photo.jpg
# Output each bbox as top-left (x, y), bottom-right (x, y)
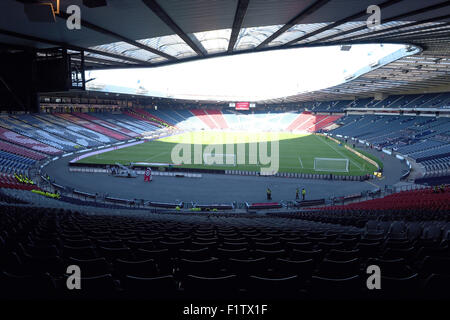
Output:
top-left (78, 131), bottom-right (380, 175)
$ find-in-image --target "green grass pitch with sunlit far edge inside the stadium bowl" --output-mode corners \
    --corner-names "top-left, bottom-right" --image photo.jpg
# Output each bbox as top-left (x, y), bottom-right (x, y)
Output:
top-left (78, 131), bottom-right (379, 175)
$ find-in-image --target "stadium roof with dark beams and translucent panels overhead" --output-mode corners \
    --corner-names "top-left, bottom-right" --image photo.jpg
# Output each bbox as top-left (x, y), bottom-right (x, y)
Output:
top-left (0, 0), bottom-right (450, 102)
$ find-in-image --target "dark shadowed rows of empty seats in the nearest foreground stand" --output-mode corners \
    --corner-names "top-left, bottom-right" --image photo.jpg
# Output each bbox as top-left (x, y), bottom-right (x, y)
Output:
top-left (0, 198), bottom-right (450, 299)
